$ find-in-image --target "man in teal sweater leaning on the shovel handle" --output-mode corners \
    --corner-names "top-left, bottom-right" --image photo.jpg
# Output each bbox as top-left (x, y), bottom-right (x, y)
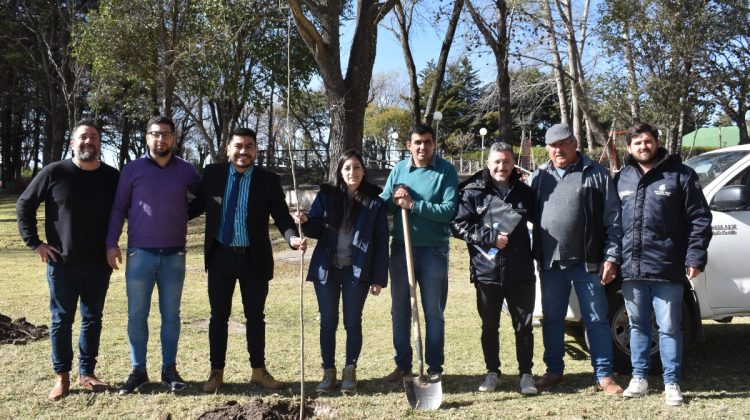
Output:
top-left (380, 124), bottom-right (458, 382)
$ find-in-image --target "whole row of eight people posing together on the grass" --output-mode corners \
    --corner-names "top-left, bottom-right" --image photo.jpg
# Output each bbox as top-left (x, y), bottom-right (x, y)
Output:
top-left (17, 117), bottom-right (711, 405)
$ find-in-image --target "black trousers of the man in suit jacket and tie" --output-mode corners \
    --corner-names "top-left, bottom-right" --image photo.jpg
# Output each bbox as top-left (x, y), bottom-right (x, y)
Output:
top-left (208, 244), bottom-right (268, 369)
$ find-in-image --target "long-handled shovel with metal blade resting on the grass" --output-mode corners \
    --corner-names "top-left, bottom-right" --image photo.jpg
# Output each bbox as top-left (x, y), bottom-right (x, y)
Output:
top-left (401, 209), bottom-right (443, 410)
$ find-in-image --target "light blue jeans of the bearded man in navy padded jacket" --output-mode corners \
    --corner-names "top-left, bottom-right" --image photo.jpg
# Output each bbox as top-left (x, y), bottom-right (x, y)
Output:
top-left (622, 280), bottom-right (683, 384)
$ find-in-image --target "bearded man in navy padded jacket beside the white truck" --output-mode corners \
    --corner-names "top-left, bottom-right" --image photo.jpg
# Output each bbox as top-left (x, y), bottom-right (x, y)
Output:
top-left (615, 123), bottom-right (711, 405)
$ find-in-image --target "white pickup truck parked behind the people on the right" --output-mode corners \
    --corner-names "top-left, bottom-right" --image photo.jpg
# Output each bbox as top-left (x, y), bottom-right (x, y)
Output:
top-left (535, 145), bottom-right (750, 373)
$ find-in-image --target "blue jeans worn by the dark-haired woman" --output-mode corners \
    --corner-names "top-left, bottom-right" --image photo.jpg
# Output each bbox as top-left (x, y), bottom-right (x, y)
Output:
top-left (314, 266), bottom-right (370, 369)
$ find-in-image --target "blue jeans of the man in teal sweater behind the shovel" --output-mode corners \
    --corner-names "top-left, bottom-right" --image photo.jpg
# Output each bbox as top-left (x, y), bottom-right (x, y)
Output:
top-left (389, 240), bottom-right (449, 373)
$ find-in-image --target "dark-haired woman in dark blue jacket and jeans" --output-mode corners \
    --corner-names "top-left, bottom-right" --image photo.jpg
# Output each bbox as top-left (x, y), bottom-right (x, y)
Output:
top-left (297, 149), bottom-right (388, 393)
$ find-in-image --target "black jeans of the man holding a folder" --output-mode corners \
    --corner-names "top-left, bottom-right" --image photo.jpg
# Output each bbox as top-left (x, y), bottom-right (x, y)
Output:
top-left (474, 282), bottom-right (536, 375)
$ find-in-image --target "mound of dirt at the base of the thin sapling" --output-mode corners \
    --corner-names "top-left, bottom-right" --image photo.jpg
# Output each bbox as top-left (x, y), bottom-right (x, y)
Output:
top-left (198, 399), bottom-right (335, 420)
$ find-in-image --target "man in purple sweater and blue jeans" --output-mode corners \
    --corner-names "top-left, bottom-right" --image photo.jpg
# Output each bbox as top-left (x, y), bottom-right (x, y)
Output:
top-left (107, 117), bottom-right (200, 395)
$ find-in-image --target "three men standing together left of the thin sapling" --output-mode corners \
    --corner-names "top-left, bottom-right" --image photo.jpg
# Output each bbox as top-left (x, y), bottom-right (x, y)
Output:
top-left (16, 117), bottom-right (307, 400)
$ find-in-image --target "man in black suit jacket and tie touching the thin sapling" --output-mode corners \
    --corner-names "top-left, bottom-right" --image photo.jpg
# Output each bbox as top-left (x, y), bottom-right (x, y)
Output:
top-left (200, 128), bottom-right (307, 392)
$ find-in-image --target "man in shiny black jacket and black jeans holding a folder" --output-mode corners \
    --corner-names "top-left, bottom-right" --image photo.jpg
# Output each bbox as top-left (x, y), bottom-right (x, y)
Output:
top-left (451, 143), bottom-right (537, 395)
